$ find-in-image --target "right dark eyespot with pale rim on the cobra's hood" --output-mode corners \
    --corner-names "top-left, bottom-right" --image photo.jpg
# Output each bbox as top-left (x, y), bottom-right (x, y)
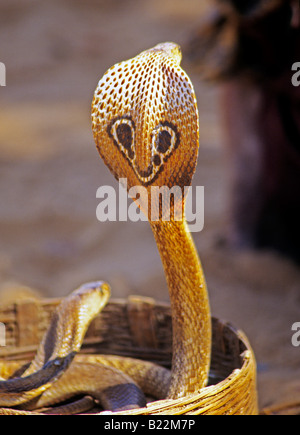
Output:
top-left (152, 121), bottom-right (180, 165)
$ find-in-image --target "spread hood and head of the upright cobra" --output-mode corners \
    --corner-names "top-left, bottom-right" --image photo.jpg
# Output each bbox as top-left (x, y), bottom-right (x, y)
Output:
top-left (92, 42), bottom-right (199, 220)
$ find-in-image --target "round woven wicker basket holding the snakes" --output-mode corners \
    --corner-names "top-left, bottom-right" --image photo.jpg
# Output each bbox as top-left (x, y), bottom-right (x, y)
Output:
top-left (0, 296), bottom-right (258, 415)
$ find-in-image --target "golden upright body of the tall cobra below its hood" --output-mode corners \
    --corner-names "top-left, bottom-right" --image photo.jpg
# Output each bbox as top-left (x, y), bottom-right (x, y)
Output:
top-left (150, 219), bottom-right (211, 399)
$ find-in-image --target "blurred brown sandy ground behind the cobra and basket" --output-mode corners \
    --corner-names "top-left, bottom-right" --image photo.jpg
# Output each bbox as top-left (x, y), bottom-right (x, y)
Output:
top-left (0, 0), bottom-right (300, 414)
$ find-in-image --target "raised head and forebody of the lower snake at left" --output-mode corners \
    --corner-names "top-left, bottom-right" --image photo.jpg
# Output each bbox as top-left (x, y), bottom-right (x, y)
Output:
top-left (0, 282), bottom-right (110, 406)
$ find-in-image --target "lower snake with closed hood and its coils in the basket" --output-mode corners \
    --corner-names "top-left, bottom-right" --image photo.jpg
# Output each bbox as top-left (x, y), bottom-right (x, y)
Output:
top-left (0, 282), bottom-right (150, 414)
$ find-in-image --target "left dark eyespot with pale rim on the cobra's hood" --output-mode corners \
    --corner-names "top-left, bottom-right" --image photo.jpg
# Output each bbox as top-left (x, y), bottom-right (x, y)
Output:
top-left (108, 118), bottom-right (134, 160)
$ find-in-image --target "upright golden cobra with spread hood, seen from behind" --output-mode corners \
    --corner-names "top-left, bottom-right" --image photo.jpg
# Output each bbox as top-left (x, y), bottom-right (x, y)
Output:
top-left (92, 42), bottom-right (211, 399)
